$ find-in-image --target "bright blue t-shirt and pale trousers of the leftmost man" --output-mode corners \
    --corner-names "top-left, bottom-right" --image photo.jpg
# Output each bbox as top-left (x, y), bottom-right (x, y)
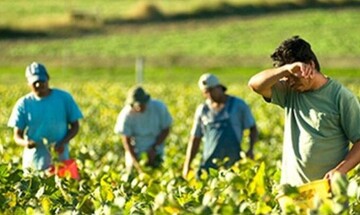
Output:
top-left (8, 89), bottom-right (83, 170)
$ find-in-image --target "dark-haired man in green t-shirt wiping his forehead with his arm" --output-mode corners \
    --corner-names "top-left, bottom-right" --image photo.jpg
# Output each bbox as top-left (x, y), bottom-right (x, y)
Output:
top-left (249, 36), bottom-right (360, 186)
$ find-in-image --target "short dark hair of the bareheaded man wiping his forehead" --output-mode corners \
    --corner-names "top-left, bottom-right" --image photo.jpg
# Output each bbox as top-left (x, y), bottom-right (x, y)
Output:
top-left (271, 36), bottom-right (320, 72)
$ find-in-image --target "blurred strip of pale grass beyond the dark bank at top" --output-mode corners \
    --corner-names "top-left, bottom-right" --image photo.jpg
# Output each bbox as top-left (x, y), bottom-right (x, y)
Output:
top-left (0, 0), bottom-right (324, 29)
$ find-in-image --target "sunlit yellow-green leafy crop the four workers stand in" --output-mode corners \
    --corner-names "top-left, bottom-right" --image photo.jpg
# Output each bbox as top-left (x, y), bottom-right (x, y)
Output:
top-left (0, 68), bottom-right (360, 214)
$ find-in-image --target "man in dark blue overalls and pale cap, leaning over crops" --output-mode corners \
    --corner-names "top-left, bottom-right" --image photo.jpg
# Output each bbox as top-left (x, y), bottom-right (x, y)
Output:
top-left (183, 73), bottom-right (258, 178)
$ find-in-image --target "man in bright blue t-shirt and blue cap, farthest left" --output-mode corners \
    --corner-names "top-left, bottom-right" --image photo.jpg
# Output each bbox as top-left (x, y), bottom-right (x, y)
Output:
top-left (8, 62), bottom-right (83, 170)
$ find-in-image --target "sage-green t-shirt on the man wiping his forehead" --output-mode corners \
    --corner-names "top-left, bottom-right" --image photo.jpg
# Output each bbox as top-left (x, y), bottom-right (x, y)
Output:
top-left (272, 79), bottom-right (360, 185)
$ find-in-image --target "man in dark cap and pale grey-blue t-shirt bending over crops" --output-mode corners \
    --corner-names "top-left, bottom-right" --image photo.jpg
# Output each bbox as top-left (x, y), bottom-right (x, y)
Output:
top-left (114, 86), bottom-right (172, 172)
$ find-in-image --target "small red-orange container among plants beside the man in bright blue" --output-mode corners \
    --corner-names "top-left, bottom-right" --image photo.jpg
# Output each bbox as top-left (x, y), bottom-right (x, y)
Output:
top-left (50, 159), bottom-right (80, 180)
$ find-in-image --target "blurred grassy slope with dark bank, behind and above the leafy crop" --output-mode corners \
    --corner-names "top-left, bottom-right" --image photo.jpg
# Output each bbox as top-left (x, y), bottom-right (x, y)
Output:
top-left (0, 0), bottom-right (360, 82)
